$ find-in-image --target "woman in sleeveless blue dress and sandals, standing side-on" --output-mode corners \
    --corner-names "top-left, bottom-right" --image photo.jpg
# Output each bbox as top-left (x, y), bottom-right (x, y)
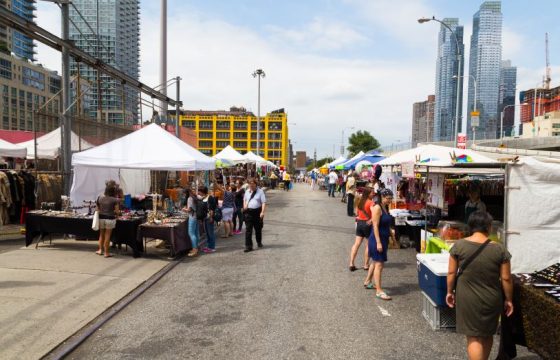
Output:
top-left (365, 189), bottom-right (393, 300)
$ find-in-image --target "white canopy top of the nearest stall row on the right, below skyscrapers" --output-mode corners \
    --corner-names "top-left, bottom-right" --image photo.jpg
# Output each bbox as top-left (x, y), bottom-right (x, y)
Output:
top-left (377, 145), bottom-right (496, 167)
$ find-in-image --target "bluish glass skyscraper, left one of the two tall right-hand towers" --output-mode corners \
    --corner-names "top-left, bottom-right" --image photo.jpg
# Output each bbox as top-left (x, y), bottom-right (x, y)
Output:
top-left (433, 18), bottom-right (465, 141)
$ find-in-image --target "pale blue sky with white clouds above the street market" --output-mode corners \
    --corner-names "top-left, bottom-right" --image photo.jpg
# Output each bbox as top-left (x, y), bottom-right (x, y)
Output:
top-left (37, 0), bottom-right (560, 157)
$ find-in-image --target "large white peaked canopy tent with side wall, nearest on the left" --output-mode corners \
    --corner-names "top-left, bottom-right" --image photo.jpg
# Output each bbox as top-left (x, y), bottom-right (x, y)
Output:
top-left (70, 124), bottom-right (216, 204)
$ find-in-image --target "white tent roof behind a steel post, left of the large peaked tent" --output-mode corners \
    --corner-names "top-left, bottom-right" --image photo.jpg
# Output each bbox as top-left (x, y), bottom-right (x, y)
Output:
top-left (18, 127), bottom-right (93, 160)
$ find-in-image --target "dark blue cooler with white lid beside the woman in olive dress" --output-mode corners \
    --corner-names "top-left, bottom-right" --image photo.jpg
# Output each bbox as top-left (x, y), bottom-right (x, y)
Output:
top-left (416, 254), bottom-right (449, 307)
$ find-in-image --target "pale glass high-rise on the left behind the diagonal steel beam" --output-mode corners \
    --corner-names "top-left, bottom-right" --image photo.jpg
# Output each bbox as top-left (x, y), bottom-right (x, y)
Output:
top-left (70, 0), bottom-right (140, 125)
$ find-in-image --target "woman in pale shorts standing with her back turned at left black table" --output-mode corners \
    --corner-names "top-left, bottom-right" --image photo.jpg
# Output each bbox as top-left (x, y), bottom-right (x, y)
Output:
top-left (95, 180), bottom-right (121, 258)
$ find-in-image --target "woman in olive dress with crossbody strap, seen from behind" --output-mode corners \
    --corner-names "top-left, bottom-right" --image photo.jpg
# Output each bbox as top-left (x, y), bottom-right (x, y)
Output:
top-left (446, 211), bottom-right (513, 359)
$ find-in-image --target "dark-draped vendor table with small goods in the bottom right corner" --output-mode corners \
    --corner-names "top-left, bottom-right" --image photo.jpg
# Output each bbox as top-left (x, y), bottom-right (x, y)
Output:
top-left (500, 280), bottom-right (560, 359)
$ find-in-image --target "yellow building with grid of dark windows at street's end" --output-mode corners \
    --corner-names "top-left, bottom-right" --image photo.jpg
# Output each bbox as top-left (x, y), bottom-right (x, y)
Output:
top-left (175, 107), bottom-right (289, 166)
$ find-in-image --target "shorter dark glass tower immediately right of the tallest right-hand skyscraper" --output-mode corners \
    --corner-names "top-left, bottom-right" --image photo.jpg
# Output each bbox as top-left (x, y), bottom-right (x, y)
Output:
top-left (496, 60), bottom-right (517, 138)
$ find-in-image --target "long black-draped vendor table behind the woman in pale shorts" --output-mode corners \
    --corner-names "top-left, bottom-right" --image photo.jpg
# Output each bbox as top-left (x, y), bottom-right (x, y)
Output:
top-left (25, 212), bottom-right (144, 257)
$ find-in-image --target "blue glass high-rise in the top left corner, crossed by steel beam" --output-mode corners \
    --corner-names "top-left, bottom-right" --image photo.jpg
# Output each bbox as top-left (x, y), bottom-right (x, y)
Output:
top-left (0, 0), bottom-right (37, 61)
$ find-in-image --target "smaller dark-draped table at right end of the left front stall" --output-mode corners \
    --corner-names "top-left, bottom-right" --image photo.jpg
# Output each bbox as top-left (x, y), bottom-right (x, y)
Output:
top-left (137, 219), bottom-right (192, 256)
